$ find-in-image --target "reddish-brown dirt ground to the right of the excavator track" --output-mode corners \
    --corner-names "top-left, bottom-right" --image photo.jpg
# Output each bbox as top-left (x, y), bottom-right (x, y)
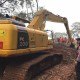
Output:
top-left (32, 44), bottom-right (76, 80)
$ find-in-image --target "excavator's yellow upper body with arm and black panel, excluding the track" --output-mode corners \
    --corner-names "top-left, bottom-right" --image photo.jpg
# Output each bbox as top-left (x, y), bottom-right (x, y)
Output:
top-left (0, 10), bottom-right (71, 57)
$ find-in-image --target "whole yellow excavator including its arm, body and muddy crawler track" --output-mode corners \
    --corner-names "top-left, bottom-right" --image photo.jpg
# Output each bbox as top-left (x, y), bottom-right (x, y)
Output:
top-left (0, 9), bottom-right (72, 80)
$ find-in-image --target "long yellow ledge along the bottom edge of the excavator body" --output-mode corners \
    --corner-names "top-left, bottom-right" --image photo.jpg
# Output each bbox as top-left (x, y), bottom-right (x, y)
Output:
top-left (0, 46), bottom-right (53, 57)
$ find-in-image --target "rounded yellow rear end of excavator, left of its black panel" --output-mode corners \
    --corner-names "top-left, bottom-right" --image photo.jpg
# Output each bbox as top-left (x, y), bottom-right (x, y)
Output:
top-left (0, 24), bottom-right (17, 50)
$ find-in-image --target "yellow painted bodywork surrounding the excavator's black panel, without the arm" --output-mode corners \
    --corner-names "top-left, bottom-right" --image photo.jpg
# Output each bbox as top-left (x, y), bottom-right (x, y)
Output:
top-left (0, 21), bottom-right (52, 57)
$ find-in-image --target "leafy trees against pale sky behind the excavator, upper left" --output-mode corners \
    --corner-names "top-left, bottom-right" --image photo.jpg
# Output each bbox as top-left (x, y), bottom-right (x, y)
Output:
top-left (0, 0), bottom-right (37, 20)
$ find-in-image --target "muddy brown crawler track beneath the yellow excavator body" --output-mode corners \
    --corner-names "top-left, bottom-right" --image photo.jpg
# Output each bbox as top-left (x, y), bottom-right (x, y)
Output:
top-left (0, 50), bottom-right (63, 80)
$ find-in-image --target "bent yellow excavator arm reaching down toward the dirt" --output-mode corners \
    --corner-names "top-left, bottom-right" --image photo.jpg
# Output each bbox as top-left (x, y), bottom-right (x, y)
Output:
top-left (28, 10), bottom-right (72, 42)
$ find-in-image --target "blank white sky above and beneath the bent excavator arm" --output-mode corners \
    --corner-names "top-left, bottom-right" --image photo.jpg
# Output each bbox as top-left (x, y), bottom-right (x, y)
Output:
top-left (38, 0), bottom-right (80, 32)
